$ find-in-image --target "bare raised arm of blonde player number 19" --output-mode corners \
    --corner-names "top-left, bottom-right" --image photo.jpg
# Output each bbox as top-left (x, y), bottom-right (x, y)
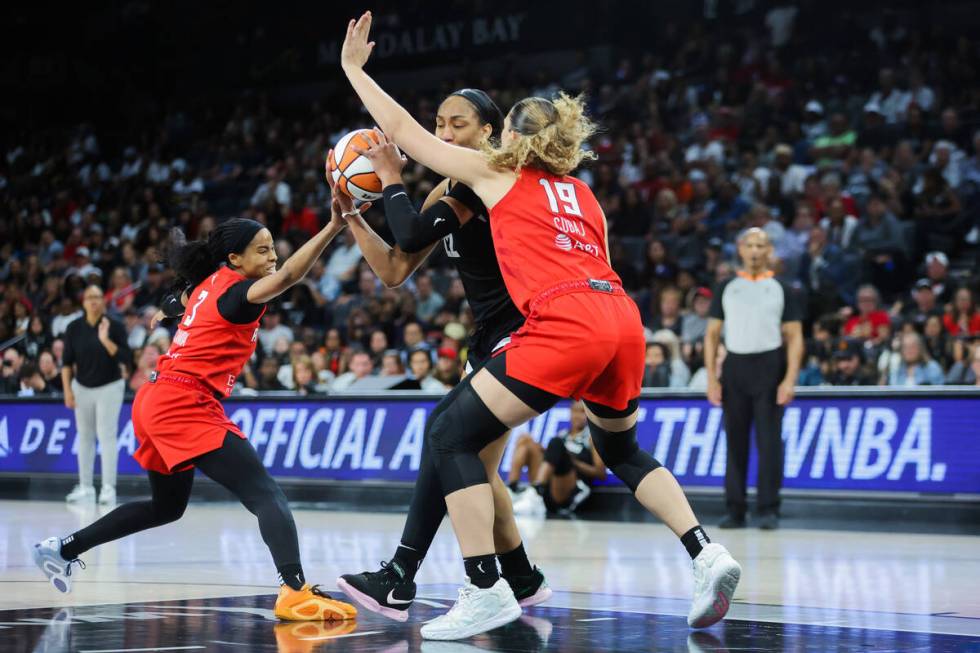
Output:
top-left (340, 11), bottom-right (494, 193)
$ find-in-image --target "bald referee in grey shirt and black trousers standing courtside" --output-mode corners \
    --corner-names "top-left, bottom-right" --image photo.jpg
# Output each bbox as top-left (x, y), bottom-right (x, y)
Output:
top-left (704, 229), bottom-right (803, 530)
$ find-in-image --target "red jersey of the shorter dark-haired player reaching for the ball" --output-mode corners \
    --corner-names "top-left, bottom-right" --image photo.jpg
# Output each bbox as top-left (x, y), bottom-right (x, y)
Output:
top-left (157, 267), bottom-right (265, 397)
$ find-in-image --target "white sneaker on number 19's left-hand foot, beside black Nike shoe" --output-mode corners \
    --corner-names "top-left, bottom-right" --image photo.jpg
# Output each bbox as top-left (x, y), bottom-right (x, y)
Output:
top-left (422, 578), bottom-right (521, 640)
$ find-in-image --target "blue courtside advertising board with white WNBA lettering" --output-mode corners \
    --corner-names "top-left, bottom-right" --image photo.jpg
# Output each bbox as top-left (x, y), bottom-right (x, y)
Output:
top-left (0, 395), bottom-right (980, 494)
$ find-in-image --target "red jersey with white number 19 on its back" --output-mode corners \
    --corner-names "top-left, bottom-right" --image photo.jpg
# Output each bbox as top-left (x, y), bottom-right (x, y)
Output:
top-left (490, 168), bottom-right (620, 316)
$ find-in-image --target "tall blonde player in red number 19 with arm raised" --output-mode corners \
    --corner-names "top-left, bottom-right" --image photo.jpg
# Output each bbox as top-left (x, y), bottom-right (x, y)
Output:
top-left (341, 12), bottom-right (741, 640)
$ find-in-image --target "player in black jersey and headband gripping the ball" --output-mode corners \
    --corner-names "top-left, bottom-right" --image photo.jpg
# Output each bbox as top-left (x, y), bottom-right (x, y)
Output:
top-left (327, 89), bottom-right (551, 621)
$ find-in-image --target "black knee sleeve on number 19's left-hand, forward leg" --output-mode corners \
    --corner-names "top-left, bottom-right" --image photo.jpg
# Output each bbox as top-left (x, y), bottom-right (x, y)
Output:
top-left (426, 381), bottom-right (507, 496)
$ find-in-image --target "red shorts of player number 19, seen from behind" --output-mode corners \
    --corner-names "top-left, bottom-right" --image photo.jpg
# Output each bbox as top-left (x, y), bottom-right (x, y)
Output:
top-left (504, 290), bottom-right (646, 410)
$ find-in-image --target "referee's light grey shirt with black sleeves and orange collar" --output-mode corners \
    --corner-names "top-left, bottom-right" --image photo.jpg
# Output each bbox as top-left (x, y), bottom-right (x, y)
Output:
top-left (708, 270), bottom-right (803, 354)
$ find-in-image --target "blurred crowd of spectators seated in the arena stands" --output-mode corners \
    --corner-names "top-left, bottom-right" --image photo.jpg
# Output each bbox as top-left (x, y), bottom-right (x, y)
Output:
top-left (0, 6), bottom-right (980, 394)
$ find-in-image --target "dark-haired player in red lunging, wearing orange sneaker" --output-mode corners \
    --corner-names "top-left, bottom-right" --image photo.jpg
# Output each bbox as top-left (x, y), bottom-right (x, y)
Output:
top-left (34, 205), bottom-right (357, 621)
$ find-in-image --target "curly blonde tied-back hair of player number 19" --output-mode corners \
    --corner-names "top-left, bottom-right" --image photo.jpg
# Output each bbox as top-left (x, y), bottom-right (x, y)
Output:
top-left (483, 93), bottom-right (596, 176)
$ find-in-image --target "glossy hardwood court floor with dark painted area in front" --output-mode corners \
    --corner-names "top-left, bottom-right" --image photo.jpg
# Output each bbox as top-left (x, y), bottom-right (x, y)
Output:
top-left (0, 501), bottom-right (980, 653)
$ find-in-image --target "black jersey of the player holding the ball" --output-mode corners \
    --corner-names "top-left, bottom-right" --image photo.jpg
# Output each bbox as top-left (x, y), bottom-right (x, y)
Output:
top-left (442, 183), bottom-right (524, 367)
